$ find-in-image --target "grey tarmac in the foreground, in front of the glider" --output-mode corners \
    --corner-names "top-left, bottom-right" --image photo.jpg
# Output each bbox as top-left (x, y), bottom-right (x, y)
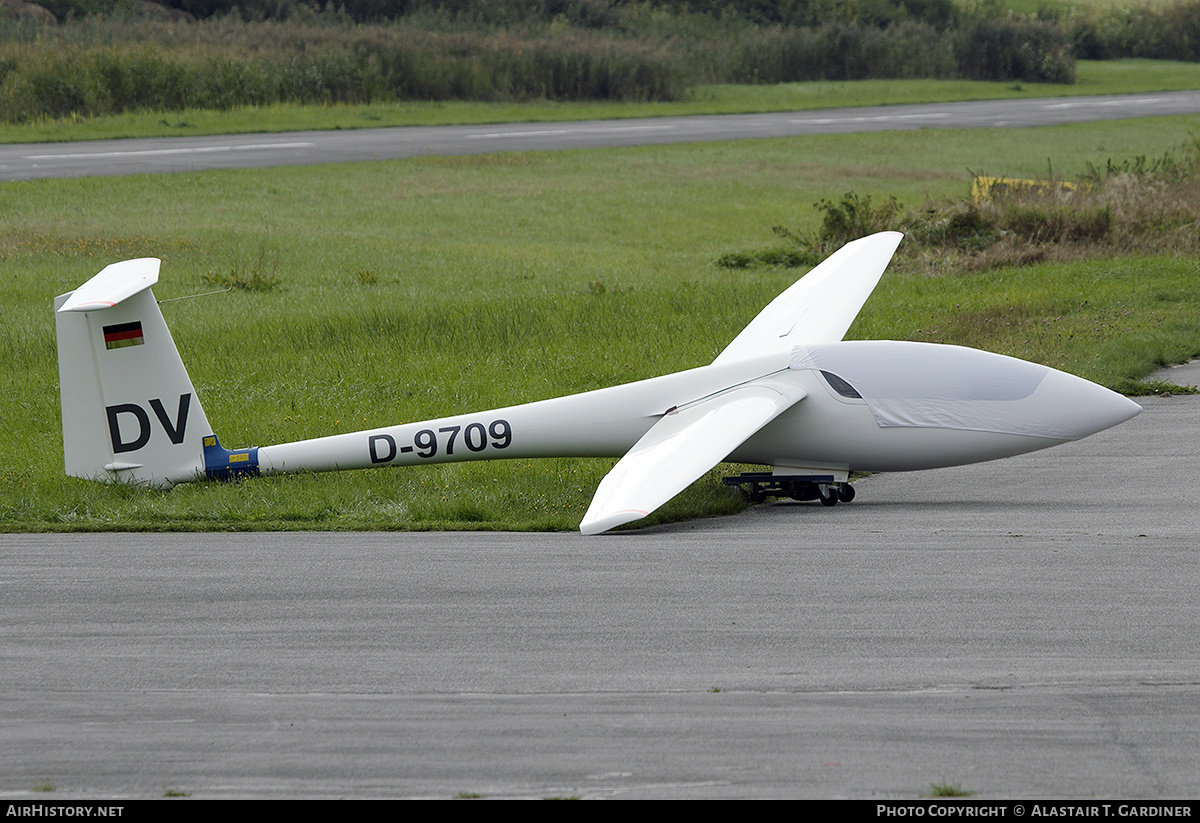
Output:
top-left (0, 397), bottom-right (1200, 803)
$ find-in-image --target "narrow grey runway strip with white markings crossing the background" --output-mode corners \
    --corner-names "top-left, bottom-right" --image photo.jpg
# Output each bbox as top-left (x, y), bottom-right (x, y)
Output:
top-left (0, 91), bottom-right (1200, 180)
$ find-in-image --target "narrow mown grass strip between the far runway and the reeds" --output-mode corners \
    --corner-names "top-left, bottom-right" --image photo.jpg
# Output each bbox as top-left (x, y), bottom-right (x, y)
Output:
top-left (0, 60), bottom-right (1200, 143)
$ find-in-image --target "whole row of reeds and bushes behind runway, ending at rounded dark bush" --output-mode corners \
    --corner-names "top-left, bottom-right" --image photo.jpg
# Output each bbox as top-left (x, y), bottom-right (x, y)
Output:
top-left (0, 0), bottom-right (1074, 122)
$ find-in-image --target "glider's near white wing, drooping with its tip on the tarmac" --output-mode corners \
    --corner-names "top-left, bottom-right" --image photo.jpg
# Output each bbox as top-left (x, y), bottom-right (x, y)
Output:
top-left (580, 379), bottom-right (805, 534)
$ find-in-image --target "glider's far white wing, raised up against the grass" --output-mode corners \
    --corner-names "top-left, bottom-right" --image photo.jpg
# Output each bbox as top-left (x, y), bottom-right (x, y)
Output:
top-left (713, 232), bottom-right (904, 364)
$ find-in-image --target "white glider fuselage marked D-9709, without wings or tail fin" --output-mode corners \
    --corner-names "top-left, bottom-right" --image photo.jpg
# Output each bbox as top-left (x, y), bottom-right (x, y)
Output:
top-left (258, 341), bottom-right (1140, 484)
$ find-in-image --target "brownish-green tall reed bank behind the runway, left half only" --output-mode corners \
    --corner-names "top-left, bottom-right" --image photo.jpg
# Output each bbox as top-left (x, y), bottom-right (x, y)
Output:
top-left (0, 20), bottom-right (686, 122)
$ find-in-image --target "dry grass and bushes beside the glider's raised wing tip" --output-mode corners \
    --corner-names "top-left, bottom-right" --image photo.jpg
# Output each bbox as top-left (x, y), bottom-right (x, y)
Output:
top-left (716, 140), bottom-right (1200, 277)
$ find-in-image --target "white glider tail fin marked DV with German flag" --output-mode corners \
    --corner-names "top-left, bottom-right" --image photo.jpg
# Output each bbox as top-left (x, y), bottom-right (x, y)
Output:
top-left (54, 258), bottom-right (216, 487)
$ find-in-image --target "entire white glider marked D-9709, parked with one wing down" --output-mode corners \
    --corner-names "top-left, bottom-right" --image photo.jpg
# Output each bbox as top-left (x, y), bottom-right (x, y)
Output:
top-left (54, 232), bottom-right (1141, 534)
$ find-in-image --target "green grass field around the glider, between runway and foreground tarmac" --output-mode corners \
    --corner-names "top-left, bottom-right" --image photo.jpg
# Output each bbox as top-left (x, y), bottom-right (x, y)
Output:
top-left (0, 118), bottom-right (1200, 530)
